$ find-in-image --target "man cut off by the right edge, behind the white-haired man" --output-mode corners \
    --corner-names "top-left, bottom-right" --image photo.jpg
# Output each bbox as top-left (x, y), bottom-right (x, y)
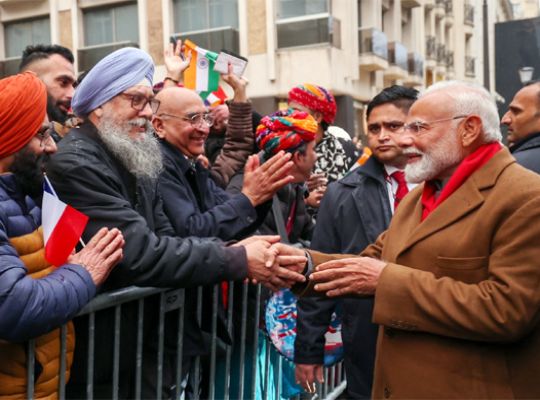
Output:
top-left (501, 81), bottom-right (540, 173)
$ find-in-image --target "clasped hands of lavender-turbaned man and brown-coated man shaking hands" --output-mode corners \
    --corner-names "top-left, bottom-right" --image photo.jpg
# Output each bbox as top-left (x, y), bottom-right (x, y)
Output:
top-left (233, 236), bottom-right (307, 291)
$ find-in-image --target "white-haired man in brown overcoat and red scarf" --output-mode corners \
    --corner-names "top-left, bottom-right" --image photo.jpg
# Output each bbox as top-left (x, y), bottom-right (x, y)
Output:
top-left (275, 81), bottom-right (540, 399)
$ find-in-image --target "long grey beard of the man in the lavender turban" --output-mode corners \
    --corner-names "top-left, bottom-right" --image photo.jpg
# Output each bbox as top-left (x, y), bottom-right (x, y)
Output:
top-left (97, 118), bottom-right (163, 179)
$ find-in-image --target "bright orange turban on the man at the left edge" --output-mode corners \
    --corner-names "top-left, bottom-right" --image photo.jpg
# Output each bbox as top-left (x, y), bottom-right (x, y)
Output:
top-left (0, 72), bottom-right (47, 158)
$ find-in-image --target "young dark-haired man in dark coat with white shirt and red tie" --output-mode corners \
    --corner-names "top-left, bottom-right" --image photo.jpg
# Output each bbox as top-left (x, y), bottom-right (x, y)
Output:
top-left (294, 86), bottom-right (418, 399)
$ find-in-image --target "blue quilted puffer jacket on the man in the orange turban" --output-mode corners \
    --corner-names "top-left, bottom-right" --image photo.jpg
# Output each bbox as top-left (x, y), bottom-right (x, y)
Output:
top-left (0, 174), bottom-right (96, 342)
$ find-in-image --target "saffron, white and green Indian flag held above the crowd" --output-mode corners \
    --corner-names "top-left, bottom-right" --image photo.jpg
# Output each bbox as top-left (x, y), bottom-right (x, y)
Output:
top-left (184, 40), bottom-right (219, 92)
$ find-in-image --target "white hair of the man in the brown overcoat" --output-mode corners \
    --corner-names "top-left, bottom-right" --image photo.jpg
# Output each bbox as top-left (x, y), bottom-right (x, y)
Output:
top-left (419, 81), bottom-right (502, 143)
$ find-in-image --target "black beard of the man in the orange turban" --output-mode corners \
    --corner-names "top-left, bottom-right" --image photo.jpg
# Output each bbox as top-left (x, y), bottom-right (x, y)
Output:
top-left (9, 147), bottom-right (49, 201)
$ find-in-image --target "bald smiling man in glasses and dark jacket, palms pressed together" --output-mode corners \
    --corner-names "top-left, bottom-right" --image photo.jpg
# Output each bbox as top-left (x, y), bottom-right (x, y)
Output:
top-left (152, 87), bottom-right (289, 240)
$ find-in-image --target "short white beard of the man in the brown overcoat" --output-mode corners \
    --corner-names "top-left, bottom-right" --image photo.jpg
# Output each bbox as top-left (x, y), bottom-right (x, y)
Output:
top-left (403, 132), bottom-right (463, 183)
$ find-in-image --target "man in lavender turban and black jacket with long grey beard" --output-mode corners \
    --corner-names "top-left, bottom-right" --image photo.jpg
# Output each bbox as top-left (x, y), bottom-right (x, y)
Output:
top-left (47, 48), bottom-right (304, 397)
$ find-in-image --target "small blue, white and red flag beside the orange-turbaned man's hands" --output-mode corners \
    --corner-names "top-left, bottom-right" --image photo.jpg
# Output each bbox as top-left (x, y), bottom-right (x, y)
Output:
top-left (41, 176), bottom-right (88, 267)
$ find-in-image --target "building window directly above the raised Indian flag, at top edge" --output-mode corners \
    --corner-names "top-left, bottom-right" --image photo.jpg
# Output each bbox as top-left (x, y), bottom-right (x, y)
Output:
top-left (173, 0), bottom-right (240, 53)
